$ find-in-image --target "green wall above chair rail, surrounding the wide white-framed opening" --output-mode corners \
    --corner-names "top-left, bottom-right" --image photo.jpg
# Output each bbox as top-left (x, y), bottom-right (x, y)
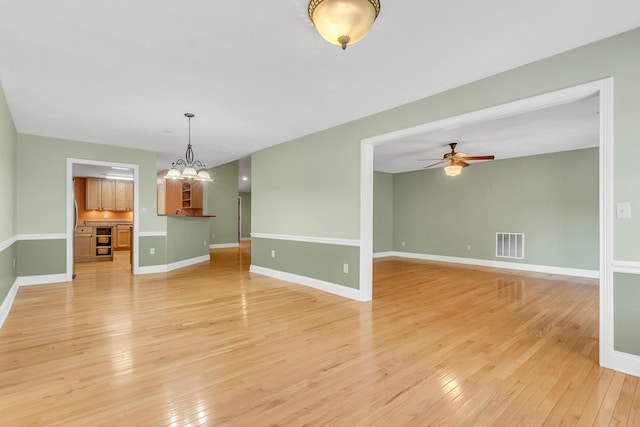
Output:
top-left (252, 29), bottom-right (640, 355)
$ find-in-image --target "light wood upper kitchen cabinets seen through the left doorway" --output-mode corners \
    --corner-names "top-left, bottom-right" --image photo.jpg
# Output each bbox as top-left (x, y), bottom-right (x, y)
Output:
top-left (85, 178), bottom-right (133, 211)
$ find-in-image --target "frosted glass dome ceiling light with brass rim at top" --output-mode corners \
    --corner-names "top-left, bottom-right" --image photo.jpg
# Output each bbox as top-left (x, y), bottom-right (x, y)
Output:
top-left (309, 0), bottom-right (380, 50)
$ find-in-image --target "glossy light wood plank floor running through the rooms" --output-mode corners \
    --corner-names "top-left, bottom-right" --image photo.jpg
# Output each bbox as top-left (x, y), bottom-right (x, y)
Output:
top-left (0, 246), bottom-right (640, 427)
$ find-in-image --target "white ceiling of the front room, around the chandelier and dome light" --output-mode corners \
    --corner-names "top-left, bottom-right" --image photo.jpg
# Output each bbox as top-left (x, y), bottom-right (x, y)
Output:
top-left (0, 0), bottom-right (640, 186)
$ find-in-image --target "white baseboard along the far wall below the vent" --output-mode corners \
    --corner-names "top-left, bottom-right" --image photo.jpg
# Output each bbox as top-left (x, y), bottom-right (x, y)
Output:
top-left (373, 251), bottom-right (600, 279)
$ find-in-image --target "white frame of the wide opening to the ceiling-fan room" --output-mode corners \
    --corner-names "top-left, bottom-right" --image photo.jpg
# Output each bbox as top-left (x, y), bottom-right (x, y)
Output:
top-left (359, 77), bottom-right (623, 370)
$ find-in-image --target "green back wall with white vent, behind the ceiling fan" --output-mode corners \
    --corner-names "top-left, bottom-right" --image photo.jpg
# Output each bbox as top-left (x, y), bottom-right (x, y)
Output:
top-left (393, 148), bottom-right (599, 270)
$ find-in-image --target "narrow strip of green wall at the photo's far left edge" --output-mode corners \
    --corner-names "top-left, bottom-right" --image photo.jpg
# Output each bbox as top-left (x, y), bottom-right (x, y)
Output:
top-left (0, 85), bottom-right (18, 303)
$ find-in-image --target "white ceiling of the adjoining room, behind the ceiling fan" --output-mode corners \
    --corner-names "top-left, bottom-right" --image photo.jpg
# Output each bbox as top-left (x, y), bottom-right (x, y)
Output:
top-left (374, 96), bottom-right (600, 173)
